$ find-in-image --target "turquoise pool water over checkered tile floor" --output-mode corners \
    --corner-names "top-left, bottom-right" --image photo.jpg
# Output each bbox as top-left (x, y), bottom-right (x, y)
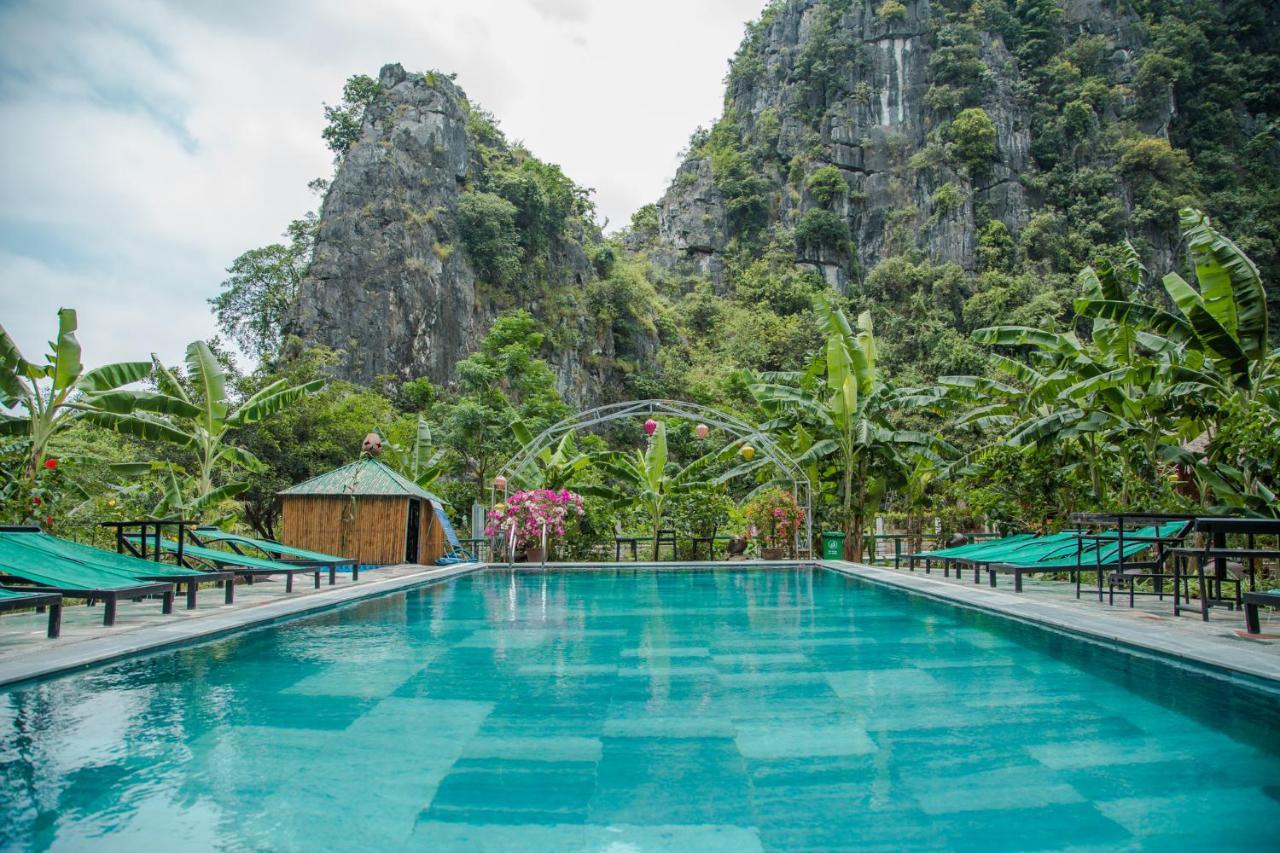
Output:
top-left (0, 570), bottom-right (1280, 853)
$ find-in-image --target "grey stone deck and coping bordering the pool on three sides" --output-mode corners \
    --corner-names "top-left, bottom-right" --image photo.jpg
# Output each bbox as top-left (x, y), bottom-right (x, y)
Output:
top-left (0, 561), bottom-right (1280, 686)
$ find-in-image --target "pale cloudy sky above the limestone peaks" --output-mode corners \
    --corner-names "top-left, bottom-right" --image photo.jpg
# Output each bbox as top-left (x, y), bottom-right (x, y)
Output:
top-left (0, 0), bottom-right (763, 365)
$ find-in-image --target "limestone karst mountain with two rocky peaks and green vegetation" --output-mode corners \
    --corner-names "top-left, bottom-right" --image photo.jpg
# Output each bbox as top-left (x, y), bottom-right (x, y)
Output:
top-left (292, 0), bottom-right (1280, 394)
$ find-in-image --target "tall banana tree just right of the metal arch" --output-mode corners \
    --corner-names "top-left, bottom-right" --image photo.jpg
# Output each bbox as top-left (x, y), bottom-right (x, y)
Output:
top-left (750, 297), bottom-right (938, 560)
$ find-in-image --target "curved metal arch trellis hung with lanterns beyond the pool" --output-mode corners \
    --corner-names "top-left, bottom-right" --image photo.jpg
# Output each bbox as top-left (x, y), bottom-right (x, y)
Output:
top-left (490, 400), bottom-right (813, 556)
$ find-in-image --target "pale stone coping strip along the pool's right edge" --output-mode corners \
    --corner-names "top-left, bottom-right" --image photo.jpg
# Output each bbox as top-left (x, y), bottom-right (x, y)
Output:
top-left (812, 560), bottom-right (1280, 689)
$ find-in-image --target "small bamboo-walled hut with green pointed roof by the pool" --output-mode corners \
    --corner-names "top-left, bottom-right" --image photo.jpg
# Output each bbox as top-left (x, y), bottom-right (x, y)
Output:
top-left (279, 457), bottom-right (445, 565)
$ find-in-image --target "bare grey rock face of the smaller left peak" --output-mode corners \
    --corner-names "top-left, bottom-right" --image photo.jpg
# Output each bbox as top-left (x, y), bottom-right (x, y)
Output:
top-left (296, 65), bottom-right (484, 382)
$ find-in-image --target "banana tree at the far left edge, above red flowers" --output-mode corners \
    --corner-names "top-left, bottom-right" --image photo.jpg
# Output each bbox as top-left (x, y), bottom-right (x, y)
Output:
top-left (0, 309), bottom-right (151, 483)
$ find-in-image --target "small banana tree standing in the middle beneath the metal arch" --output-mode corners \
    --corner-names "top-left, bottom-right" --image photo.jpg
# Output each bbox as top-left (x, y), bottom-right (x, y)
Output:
top-left (579, 423), bottom-right (733, 560)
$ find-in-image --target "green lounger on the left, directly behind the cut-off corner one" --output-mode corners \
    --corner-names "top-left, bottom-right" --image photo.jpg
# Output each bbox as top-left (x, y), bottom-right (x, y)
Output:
top-left (0, 528), bottom-right (173, 625)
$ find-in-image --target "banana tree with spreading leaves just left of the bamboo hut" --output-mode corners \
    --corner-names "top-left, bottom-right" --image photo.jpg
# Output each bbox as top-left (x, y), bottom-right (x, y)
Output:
top-left (84, 341), bottom-right (324, 512)
